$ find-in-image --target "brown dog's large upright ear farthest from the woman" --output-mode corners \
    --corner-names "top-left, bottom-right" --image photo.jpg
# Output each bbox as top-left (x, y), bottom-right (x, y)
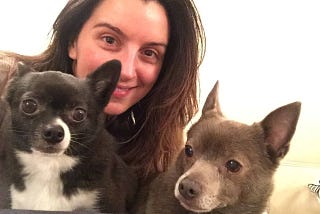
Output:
top-left (260, 102), bottom-right (301, 159)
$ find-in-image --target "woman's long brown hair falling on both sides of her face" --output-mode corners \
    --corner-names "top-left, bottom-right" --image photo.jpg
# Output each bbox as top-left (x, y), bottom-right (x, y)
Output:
top-left (5, 0), bottom-right (205, 182)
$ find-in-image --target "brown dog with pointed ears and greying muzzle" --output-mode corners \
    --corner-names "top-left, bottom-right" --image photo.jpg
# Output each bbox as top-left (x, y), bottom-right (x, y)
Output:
top-left (135, 82), bottom-right (301, 214)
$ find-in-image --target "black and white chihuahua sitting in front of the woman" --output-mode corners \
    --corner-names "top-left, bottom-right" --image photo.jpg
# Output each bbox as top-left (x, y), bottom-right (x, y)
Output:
top-left (0, 60), bottom-right (137, 212)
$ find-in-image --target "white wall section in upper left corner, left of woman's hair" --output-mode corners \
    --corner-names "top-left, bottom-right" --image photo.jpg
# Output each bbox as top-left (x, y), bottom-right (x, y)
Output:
top-left (0, 0), bottom-right (67, 55)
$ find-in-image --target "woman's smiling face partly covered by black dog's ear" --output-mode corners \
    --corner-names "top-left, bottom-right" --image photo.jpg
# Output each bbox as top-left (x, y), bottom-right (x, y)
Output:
top-left (69, 0), bottom-right (169, 115)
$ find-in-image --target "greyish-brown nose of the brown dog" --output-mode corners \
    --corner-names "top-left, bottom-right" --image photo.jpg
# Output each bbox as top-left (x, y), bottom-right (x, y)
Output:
top-left (179, 179), bottom-right (201, 200)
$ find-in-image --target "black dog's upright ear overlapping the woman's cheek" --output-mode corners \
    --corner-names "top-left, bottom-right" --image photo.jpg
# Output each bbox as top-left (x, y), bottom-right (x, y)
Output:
top-left (87, 60), bottom-right (121, 107)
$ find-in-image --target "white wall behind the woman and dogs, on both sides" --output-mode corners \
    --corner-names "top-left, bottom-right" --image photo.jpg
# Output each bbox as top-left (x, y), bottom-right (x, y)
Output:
top-left (0, 0), bottom-right (320, 165)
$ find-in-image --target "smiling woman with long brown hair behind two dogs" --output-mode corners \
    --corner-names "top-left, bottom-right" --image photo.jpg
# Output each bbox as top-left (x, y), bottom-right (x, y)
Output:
top-left (0, 0), bottom-right (205, 184)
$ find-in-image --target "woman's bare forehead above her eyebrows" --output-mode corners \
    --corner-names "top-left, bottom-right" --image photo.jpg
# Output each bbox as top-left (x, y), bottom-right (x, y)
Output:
top-left (88, 0), bottom-right (169, 44)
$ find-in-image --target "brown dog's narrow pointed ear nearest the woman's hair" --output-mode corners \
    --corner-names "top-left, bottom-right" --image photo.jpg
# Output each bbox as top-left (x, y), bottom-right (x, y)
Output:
top-left (202, 81), bottom-right (223, 117)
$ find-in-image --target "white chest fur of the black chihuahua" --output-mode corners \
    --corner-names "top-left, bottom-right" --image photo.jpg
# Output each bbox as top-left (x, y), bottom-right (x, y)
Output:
top-left (11, 152), bottom-right (98, 211)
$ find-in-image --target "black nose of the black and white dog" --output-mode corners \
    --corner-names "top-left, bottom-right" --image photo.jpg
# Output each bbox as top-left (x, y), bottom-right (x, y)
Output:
top-left (42, 124), bottom-right (64, 144)
